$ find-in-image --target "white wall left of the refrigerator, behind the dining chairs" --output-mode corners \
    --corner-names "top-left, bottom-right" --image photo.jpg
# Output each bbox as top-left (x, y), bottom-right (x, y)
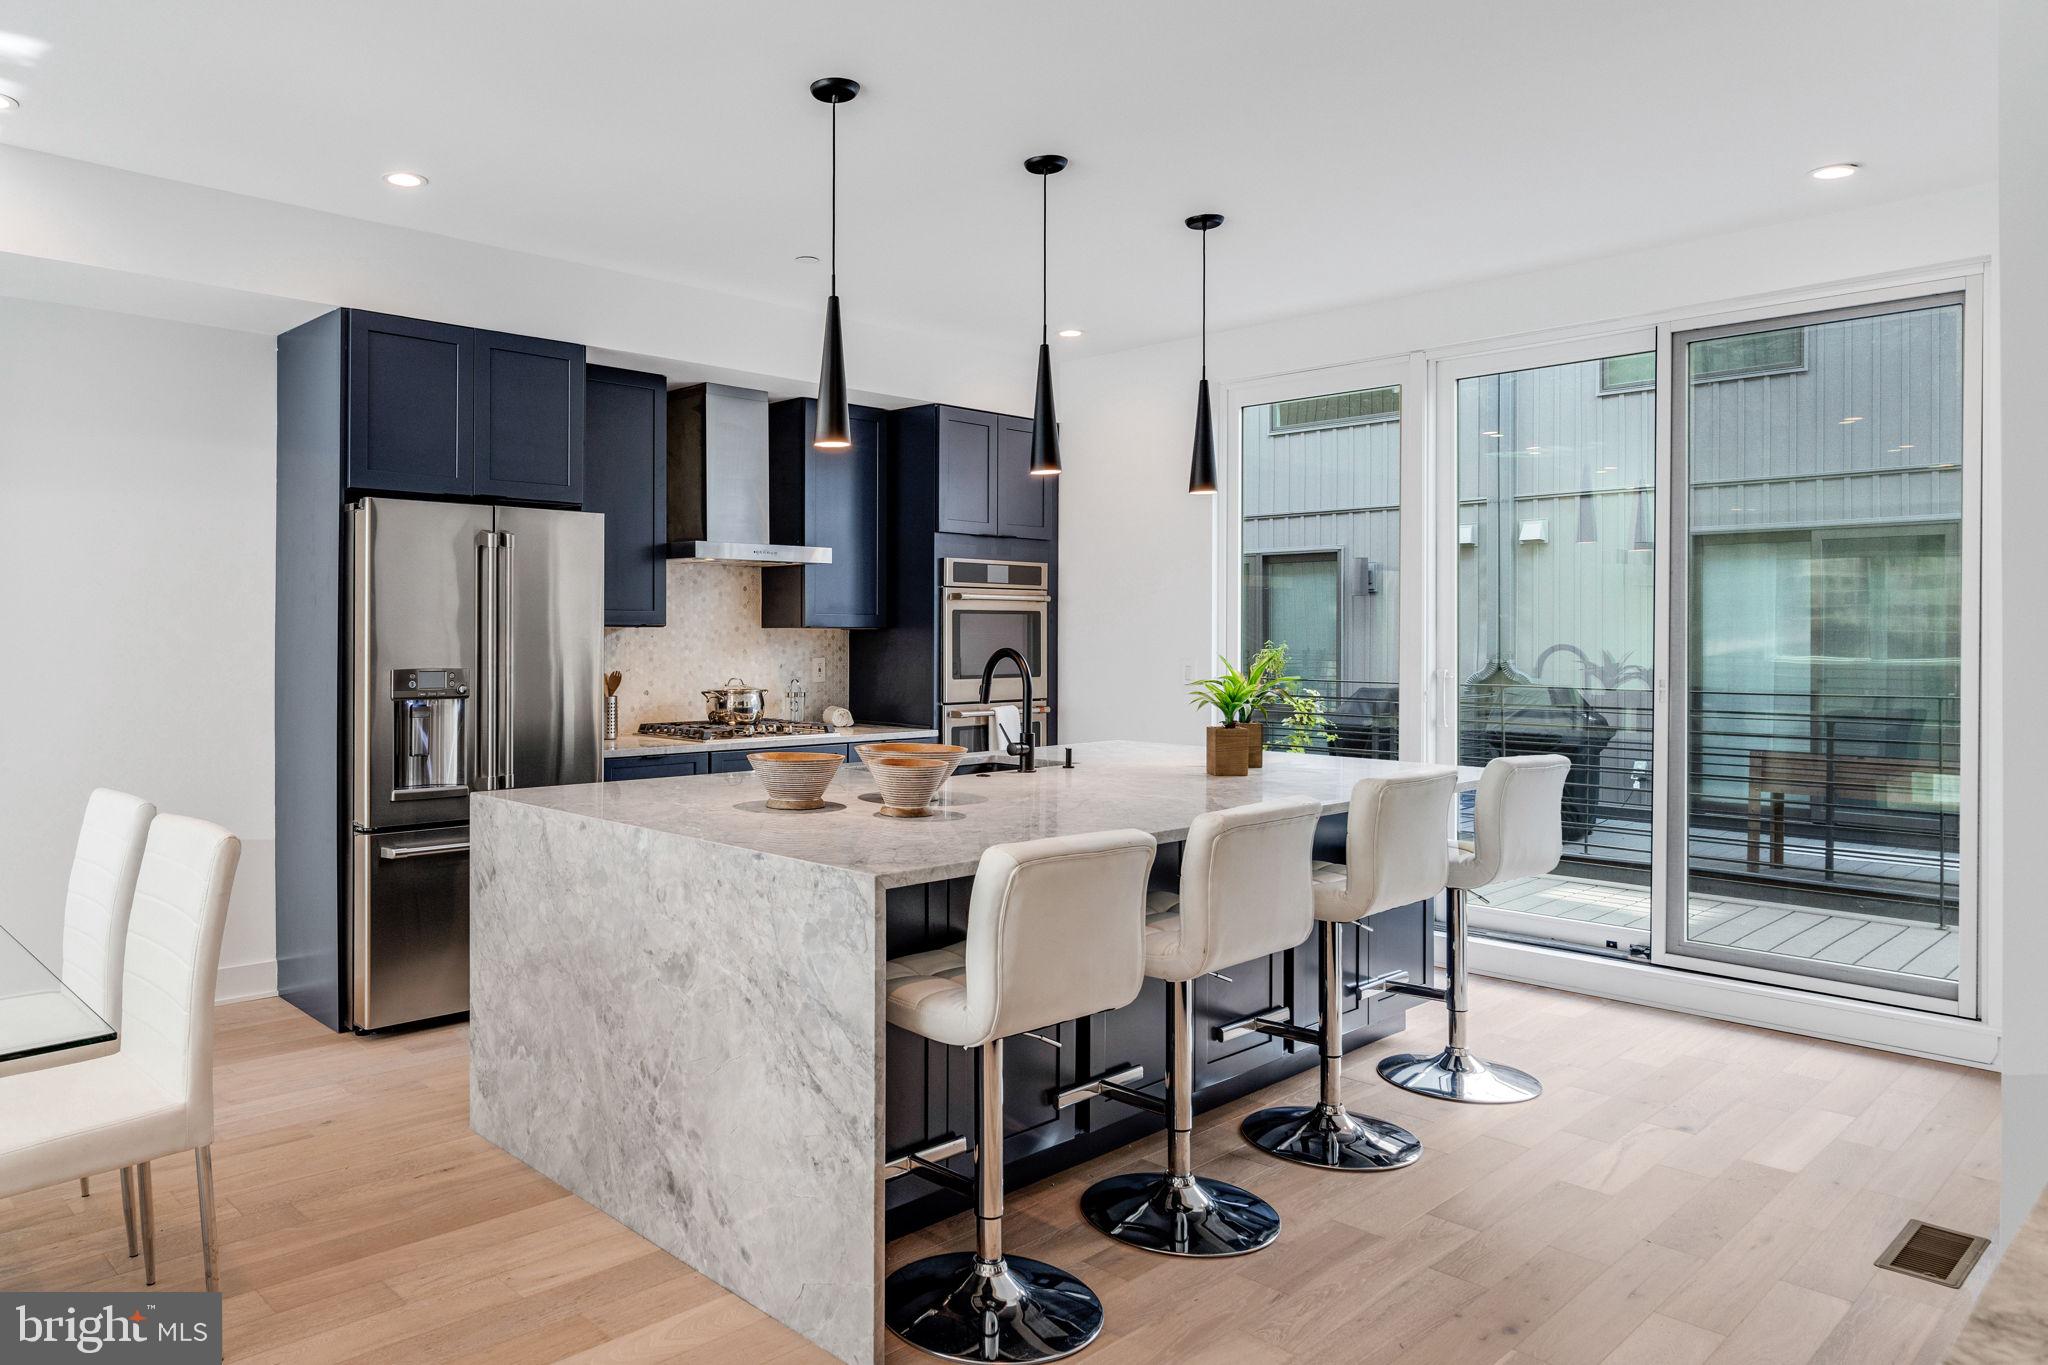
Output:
top-left (0, 299), bottom-right (276, 999)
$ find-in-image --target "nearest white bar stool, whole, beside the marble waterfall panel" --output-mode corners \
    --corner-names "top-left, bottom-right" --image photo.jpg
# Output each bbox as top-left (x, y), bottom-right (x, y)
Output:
top-left (883, 829), bottom-right (1157, 1361)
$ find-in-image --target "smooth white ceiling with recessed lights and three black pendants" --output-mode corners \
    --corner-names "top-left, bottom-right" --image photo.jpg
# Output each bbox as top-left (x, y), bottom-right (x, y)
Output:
top-left (0, 0), bottom-right (1997, 354)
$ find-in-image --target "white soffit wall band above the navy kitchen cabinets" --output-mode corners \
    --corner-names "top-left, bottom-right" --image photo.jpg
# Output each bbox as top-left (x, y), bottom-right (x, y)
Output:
top-left (0, 145), bottom-right (1032, 411)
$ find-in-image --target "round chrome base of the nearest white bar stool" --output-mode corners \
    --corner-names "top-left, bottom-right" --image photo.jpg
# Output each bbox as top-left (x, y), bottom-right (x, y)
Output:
top-left (883, 1250), bottom-right (1102, 1361)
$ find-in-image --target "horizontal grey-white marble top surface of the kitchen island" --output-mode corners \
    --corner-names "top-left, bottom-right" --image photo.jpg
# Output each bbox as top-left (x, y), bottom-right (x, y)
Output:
top-left (485, 741), bottom-right (1479, 888)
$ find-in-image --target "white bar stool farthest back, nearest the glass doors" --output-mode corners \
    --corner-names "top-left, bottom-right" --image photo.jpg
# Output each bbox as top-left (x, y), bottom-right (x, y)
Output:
top-left (1380, 753), bottom-right (1571, 1105)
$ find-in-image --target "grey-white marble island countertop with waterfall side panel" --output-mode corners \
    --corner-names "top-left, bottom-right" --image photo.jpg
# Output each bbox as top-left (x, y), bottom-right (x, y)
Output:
top-left (469, 743), bottom-right (1477, 1365)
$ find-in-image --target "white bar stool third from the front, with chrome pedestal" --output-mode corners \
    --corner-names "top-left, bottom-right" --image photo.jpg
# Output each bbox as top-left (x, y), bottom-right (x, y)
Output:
top-left (1241, 767), bottom-right (1458, 1171)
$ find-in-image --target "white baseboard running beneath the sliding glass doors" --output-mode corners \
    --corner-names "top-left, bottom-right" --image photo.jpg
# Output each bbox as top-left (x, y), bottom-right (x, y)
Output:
top-left (1438, 933), bottom-right (1999, 1070)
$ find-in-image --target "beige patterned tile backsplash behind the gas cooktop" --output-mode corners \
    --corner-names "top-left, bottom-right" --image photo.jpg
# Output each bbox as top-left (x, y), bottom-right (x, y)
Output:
top-left (604, 559), bottom-right (850, 735)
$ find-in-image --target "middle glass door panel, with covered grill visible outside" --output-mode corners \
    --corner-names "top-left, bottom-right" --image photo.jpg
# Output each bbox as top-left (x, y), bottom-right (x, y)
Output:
top-left (1434, 334), bottom-right (1657, 954)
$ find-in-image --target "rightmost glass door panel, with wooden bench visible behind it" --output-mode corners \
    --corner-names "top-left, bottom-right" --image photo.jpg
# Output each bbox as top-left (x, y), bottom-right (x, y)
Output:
top-left (1659, 295), bottom-right (1978, 1009)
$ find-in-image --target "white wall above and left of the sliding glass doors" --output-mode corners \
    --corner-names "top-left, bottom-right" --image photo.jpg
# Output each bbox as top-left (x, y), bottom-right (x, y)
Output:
top-left (1059, 186), bottom-right (1997, 743)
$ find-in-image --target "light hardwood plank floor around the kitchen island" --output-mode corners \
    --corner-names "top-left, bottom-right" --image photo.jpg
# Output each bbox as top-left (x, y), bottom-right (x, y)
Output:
top-left (0, 980), bottom-right (1999, 1365)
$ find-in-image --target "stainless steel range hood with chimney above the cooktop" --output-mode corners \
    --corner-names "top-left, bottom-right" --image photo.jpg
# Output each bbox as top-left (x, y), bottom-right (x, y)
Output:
top-left (668, 385), bottom-right (831, 565)
